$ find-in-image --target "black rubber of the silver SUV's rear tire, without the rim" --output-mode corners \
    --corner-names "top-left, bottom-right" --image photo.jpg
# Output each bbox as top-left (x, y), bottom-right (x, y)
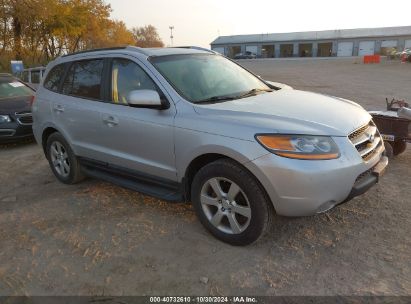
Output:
top-left (46, 132), bottom-right (84, 185)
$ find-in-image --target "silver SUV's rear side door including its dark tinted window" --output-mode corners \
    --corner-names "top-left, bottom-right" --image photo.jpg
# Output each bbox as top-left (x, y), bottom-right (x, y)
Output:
top-left (52, 58), bottom-right (105, 159)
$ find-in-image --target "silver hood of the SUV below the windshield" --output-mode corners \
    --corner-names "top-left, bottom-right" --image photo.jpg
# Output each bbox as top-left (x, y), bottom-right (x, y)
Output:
top-left (194, 90), bottom-right (371, 139)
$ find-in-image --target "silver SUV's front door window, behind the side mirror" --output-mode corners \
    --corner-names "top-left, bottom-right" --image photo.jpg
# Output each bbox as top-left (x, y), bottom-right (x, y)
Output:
top-left (111, 59), bottom-right (157, 104)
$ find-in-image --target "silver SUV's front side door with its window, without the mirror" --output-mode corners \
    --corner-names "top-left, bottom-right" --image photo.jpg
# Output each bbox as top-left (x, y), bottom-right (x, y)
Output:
top-left (96, 55), bottom-right (177, 181)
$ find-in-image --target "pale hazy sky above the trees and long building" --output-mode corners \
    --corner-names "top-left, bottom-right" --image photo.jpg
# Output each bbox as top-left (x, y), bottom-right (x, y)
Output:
top-left (106, 0), bottom-right (411, 47)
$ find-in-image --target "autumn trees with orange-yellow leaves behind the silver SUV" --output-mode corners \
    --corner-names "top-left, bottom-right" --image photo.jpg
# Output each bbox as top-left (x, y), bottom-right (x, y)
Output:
top-left (0, 0), bottom-right (164, 71)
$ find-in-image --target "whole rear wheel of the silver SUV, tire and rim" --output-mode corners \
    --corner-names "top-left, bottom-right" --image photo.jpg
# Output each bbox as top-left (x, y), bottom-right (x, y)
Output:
top-left (46, 132), bottom-right (84, 185)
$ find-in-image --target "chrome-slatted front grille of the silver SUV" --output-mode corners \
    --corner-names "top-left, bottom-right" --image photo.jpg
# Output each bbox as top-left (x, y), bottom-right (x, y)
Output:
top-left (348, 121), bottom-right (383, 161)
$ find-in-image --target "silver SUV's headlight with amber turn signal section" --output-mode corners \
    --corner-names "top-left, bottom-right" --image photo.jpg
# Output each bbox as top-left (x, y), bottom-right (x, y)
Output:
top-left (256, 134), bottom-right (340, 160)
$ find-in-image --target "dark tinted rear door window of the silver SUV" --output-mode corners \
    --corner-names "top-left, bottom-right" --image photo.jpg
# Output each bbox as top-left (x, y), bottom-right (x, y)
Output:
top-left (63, 59), bottom-right (103, 99)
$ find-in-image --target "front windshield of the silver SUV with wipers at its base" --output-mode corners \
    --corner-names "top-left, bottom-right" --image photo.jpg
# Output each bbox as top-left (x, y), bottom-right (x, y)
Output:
top-left (150, 54), bottom-right (271, 103)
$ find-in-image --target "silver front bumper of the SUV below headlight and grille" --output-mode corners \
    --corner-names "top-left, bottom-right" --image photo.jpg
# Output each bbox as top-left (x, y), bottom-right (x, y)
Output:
top-left (244, 137), bottom-right (388, 216)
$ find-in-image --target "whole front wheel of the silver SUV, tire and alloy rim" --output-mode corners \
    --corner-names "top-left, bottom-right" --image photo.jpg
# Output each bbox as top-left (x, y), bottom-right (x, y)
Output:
top-left (191, 159), bottom-right (274, 246)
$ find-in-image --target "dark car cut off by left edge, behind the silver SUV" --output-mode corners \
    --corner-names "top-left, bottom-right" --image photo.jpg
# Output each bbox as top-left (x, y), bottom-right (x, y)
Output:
top-left (0, 74), bottom-right (35, 143)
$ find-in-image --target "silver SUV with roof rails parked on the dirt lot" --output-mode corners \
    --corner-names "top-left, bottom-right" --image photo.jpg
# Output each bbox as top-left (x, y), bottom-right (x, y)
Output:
top-left (33, 47), bottom-right (388, 245)
